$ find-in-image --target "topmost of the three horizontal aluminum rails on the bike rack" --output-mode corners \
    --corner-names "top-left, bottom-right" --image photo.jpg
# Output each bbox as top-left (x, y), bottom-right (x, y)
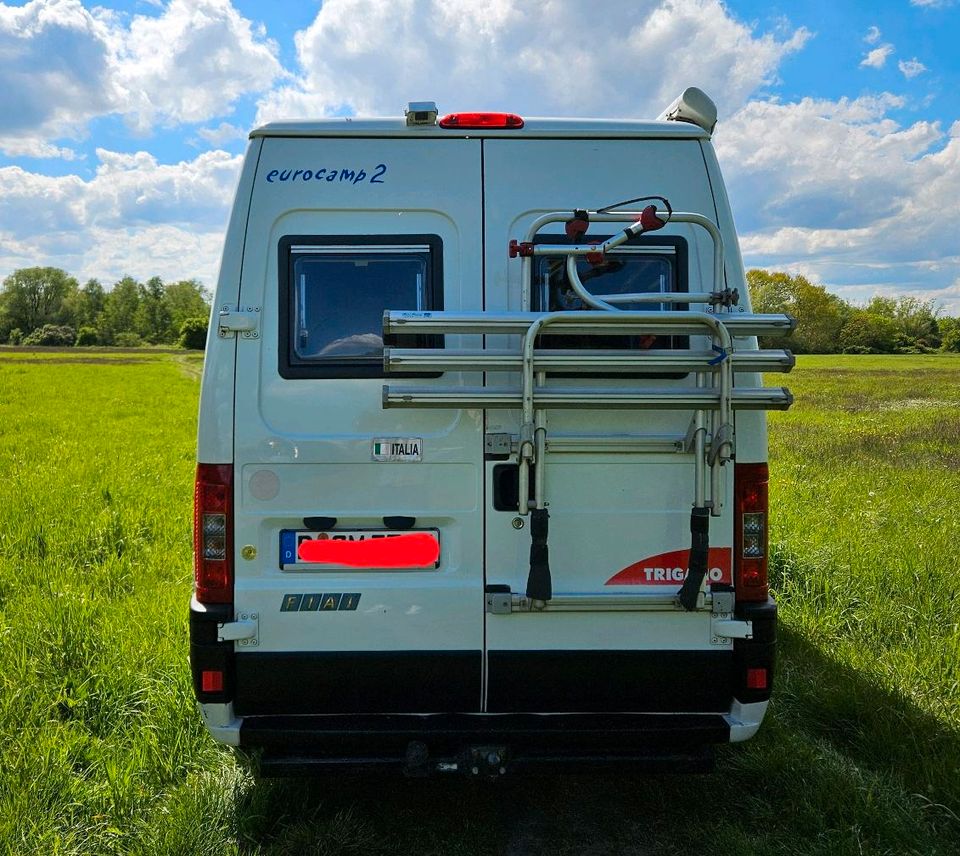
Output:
top-left (383, 309), bottom-right (797, 338)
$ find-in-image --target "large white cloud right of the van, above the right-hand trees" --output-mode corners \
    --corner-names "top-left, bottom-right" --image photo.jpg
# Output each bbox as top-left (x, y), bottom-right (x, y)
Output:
top-left (716, 95), bottom-right (960, 312)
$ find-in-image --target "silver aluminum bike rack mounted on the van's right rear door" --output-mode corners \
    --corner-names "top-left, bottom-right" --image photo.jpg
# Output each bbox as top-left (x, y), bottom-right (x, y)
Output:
top-left (383, 206), bottom-right (796, 609)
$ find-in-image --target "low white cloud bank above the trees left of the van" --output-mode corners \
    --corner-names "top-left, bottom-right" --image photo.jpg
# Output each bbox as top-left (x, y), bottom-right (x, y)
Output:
top-left (0, 149), bottom-right (242, 284)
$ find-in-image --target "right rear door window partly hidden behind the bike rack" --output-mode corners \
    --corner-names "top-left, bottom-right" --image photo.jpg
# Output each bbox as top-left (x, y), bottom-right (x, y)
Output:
top-left (532, 235), bottom-right (688, 349)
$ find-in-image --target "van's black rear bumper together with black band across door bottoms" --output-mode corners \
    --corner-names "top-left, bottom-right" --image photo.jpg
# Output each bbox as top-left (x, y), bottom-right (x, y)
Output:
top-left (191, 600), bottom-right (777, 775)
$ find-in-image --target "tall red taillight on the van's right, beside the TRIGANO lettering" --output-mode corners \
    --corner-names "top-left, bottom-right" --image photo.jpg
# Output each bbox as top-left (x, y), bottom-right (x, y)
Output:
top-left (733, 464), bottom-right (769, 601)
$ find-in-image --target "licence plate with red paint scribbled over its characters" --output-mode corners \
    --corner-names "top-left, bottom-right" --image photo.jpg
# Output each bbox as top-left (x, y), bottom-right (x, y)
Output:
top-left (280, 529), bottom-right (440, 571)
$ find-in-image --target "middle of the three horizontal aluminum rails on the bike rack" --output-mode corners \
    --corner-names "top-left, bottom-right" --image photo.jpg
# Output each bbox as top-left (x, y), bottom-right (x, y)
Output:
top-left (383, 348), bottom-right (796, 374)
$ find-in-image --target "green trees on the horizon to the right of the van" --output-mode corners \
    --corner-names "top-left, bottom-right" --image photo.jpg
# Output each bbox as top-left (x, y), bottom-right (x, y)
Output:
top-left (747, 270), bottom-right (960, 354)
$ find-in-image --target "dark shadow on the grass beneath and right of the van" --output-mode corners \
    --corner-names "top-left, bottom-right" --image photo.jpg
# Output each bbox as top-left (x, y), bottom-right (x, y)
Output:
top-left (221, 630), bottom-right (960, 856)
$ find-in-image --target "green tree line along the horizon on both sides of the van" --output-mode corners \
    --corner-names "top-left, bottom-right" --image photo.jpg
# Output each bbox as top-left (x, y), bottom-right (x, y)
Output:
top-left (0, 267), bottom-right (960, 354)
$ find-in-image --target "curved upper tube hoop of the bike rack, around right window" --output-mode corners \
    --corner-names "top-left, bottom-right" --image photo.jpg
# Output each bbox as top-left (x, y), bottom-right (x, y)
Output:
top-left (520, 211), bottom-right (725, 311)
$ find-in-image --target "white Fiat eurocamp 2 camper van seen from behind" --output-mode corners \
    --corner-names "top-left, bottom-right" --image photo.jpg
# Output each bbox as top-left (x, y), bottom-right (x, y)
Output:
top-left (190, 89), bottom-right (793, 775)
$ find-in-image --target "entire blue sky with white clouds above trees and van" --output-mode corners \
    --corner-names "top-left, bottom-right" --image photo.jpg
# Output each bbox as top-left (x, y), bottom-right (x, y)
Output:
top-left (0, 0), bottom-right (960, 314)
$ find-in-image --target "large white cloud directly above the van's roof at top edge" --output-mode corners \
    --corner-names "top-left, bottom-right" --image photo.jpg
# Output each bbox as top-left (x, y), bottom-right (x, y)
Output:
top-left (258, 0), bottom-right (810, 121)
